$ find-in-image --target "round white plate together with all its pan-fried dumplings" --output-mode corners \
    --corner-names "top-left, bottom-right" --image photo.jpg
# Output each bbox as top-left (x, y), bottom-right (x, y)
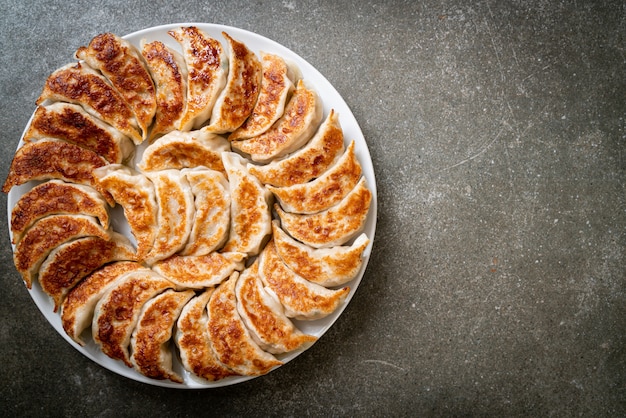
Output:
top-left (2, 24), bottom-right (376, 388)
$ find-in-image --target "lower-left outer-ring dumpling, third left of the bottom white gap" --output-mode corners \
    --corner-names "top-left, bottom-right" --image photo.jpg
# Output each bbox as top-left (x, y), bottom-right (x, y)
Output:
top-left (61, 261), bottom-right (147, 346)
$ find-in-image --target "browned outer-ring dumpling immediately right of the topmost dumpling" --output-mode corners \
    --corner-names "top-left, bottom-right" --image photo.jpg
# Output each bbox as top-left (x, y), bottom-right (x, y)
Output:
top-left (203, 32), bottom-right (262, 134)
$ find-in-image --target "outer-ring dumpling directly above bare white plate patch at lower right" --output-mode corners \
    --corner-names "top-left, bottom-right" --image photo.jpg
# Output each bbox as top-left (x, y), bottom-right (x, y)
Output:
top-left (259, 240), bottom-right (350, 319)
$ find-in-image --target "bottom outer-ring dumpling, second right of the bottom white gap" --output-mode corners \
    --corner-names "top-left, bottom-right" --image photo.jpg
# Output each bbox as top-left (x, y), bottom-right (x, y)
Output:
top-left (207, 272), bottom-right (282, 376)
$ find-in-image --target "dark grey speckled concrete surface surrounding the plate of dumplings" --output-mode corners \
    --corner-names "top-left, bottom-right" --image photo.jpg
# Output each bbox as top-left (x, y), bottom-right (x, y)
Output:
top-left (0, 0), bottom-right (626, 417)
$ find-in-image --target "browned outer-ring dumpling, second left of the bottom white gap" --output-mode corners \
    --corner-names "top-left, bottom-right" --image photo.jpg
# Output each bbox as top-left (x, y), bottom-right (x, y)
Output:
top-left (91, 269), bottom-right (174, 367)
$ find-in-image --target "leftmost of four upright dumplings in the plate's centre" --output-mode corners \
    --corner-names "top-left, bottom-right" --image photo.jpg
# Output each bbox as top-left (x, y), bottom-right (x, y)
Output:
top-left (94, 164), bottom-right (159, 260)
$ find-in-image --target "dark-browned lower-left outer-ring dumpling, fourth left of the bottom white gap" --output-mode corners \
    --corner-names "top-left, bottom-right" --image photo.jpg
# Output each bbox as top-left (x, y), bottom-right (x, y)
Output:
top-left (38, 231), bottom-right (135, 312)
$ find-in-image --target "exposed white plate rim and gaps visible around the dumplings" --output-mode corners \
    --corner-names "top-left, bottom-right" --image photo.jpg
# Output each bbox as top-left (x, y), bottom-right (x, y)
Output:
top-left (7, 23), bottom-right (377, 388)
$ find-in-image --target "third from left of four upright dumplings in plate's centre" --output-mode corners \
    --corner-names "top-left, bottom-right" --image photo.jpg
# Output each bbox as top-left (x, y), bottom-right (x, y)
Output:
top-left (181, 167), bottom-right (230, 255)
